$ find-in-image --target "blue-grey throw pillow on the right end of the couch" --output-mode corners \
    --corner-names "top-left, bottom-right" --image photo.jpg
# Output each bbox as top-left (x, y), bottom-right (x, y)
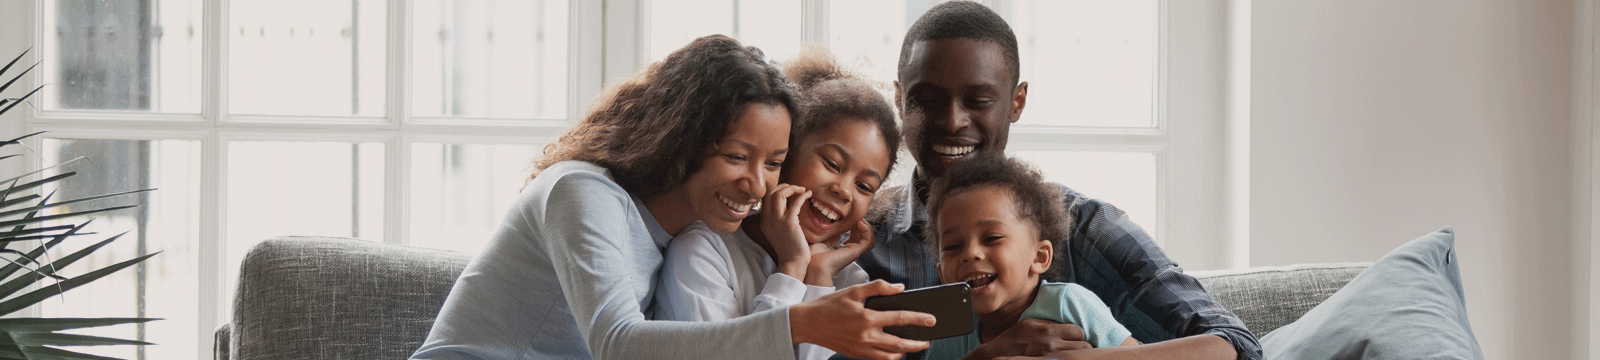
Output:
top-left (1261, 227), bottom-right (1483, 360)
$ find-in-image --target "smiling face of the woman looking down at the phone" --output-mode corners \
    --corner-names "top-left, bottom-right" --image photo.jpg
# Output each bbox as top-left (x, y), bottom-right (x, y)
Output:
top-left (683, 102), bottom-right (789, 234)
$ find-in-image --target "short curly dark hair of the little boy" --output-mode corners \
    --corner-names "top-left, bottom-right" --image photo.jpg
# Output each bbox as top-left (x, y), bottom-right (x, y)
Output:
top-left (923, 155), bottom-right (1074, 252)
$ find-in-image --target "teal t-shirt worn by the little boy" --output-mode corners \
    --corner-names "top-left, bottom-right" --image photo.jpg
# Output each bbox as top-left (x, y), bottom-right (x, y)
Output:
top-left (928, 282), bottom-right (1133, 360)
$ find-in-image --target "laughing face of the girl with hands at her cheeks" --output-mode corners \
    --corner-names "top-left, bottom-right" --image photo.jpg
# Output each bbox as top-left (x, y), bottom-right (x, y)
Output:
top-left (786, 117), bottom-right (890, 243)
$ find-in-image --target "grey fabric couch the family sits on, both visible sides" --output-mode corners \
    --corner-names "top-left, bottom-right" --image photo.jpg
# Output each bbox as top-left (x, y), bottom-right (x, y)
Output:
top-left (216, 237), bottom-right (1368, 360)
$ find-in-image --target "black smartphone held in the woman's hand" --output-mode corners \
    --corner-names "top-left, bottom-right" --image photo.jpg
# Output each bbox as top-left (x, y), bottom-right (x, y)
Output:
top-left (866, 283), bottom-right (978, 341)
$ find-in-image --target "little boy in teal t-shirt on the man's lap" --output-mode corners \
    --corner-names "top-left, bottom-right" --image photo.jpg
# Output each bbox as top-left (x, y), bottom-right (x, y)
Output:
top-left (925, 157), bottom-right (1138, 358)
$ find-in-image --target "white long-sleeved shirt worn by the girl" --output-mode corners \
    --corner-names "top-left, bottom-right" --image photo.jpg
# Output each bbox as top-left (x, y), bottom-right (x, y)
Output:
top-left (654, 222), bottom-right (867, 358)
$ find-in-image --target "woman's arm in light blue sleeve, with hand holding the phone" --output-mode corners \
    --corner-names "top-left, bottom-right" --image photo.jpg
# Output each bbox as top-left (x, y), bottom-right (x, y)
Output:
top-left (533, 173), bottom-right (933, 358)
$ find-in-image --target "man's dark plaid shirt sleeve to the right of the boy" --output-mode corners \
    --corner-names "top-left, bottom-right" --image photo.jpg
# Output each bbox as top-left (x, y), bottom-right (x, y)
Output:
top-left (1046, 186), bottom-right (1262, 360)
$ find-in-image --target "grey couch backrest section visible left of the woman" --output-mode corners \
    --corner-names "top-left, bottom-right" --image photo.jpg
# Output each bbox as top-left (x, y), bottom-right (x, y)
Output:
top-left (230, 237), bottom-right (470, 358)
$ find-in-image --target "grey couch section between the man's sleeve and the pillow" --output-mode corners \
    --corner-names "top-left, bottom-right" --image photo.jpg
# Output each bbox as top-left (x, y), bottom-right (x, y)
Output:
top-left (1190, 262), bottom-right (1371, 336)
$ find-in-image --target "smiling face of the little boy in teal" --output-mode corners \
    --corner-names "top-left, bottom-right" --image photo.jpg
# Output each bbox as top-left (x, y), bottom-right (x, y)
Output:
top-left (933, 186), bottom-right (1053, 322)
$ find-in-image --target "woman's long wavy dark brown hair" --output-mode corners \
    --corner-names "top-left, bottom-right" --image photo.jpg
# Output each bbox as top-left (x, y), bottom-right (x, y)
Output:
top-left (533, 35), bottom-right (800, 198)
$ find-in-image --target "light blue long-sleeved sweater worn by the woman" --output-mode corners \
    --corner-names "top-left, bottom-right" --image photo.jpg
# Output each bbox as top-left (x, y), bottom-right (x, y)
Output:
top-left (411, 162), bottom-right (795, 358)
